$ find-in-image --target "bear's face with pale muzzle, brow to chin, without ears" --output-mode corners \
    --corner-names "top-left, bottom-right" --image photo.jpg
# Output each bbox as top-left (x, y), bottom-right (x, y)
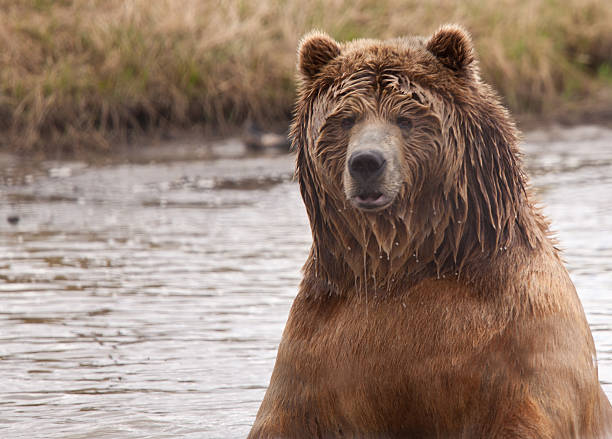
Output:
top-left (330, 83), bottom-right (445, 212)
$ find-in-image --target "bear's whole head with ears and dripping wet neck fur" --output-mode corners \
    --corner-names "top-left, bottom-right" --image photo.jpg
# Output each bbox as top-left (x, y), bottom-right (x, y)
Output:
top-left (291, 25), bottom-right (526, 290)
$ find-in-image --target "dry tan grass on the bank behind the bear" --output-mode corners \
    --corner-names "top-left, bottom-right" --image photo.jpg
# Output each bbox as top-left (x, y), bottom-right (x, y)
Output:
top-left (0, 0), bottom-right (612, 151)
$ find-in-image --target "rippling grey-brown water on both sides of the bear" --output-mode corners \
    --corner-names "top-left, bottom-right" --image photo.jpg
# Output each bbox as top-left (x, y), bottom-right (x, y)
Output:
top-left (0, 128), bottom-right (612, 438)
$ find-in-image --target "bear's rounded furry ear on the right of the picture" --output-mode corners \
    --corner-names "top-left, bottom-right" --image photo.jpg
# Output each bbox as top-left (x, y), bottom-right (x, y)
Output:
top-left (426, 24), bottom-right (474, 71)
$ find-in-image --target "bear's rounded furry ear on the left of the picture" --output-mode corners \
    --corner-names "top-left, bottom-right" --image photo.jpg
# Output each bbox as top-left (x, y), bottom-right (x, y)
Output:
top-left (298, 31), bottom-right (340, 81)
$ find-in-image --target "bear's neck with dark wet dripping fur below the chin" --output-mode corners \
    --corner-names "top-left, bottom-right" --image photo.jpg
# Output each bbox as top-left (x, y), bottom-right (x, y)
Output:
top-left (302, 186), bottom-right (552, 296)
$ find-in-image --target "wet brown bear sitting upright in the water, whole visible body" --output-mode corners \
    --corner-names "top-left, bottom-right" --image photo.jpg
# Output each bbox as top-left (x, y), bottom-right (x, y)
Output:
top-left (249, 26), bottom-right (612, 438)
